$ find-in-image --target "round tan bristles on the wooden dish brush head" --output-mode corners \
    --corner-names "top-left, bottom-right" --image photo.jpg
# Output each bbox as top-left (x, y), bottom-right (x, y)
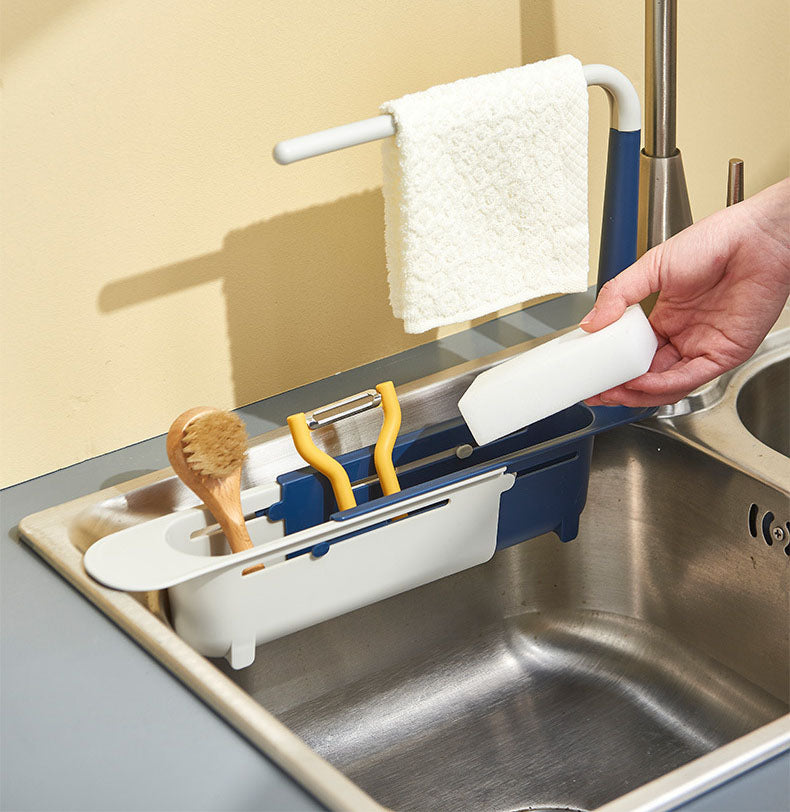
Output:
top-left (181, 411), bottom-right (247, 477)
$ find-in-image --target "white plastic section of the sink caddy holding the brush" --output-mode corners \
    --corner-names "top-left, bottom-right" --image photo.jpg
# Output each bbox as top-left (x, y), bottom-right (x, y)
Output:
top-left (84, 467), bottom-right (515, 668)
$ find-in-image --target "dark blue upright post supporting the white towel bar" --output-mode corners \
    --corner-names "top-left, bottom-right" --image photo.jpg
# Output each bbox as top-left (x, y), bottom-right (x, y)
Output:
top-left (598, 129), bottom-right (641, 290)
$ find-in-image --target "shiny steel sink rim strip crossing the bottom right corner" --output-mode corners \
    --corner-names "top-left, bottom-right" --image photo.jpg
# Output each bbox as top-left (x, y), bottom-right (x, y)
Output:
top-left (596, 714), bottom-right (790, 812)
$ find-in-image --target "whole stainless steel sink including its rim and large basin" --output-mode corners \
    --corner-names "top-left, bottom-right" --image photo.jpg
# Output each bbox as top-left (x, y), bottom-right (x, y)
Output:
top-left (21, 318), bottom-right (790, 810)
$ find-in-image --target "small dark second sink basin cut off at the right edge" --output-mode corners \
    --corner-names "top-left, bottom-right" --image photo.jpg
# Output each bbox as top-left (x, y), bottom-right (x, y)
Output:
top-left (737, 358), bottom-right (790, 457)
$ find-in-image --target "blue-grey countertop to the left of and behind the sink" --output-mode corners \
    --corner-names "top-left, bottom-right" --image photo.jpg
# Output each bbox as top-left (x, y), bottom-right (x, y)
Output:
top-left (0, 290), bottom-right (594, 811)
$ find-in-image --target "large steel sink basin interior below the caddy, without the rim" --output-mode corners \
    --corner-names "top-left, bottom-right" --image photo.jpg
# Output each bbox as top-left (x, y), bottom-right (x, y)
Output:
top-left (217, 427), bottom-right (790, 810)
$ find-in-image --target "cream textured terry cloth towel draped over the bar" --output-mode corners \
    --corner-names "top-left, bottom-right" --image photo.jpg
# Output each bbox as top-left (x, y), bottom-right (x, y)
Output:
top-left (381, 56), bottom-right (589, 333)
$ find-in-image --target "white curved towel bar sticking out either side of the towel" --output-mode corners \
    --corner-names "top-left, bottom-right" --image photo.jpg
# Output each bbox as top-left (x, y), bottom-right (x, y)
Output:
top-left (273, 65), bottom-right (642, 164)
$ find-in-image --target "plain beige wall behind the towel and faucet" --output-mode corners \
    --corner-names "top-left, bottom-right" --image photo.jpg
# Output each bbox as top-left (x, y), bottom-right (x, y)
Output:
top-left (0, 0), bottom-right (790, 485)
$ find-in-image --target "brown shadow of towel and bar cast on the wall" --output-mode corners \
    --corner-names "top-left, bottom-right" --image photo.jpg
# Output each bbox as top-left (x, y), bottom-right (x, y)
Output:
top-left (99, 189), bottom-right (428, 405)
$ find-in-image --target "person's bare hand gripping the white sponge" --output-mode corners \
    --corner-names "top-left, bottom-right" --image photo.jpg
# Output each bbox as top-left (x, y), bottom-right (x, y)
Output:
top-left (581, 178), bottom-right (790, 406)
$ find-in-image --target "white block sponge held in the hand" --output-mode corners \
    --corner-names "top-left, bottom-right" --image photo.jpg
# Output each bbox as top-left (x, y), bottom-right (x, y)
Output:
top-left (458, 305), bottom-right (658, 445)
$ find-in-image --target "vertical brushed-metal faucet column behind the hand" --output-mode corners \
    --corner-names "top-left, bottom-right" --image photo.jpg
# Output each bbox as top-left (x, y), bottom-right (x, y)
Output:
top-left (637, 0), bottom-right (693, 256)
